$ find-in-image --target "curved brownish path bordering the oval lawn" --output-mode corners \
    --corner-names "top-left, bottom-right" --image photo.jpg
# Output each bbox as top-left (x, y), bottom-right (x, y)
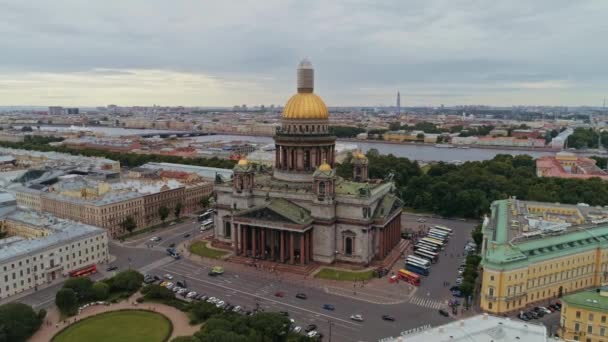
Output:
top-left (29, 293), bottom-right (201, 342)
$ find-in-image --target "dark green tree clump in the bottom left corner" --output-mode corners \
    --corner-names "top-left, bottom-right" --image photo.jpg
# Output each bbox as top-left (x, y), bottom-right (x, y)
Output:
top-left (0, 303), bottom-right (44, 342)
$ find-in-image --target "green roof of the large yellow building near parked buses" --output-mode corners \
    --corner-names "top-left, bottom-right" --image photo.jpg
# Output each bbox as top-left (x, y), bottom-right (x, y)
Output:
top-left (482, 199), bottom-right (608, 268)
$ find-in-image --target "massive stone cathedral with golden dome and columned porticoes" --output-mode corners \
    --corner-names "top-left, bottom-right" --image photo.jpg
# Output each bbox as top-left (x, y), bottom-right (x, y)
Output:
top-left (214, 59), bottom-right (403, 265)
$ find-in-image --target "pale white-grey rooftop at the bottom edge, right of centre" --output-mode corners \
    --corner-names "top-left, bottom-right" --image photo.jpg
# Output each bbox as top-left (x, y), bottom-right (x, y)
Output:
top-left (380, 314), bottom-right (555, 342)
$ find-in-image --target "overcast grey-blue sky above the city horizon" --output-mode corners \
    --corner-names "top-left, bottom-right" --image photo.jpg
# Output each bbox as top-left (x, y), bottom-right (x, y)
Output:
top-left (0, 0), bottom-right (608, 106)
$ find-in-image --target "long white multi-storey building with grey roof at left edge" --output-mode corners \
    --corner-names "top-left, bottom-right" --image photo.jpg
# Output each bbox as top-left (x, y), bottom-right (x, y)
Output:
top-left (0, 206), bottom-right (109, 299)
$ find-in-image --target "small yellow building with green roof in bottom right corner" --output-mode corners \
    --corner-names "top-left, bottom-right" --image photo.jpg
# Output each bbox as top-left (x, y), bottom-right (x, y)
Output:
top-left (559, 286), bottom-right (608, 342)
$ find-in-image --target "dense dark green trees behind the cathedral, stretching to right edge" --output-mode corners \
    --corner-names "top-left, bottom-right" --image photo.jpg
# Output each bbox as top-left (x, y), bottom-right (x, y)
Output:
top-left (337, 149), bottom-right (608, 218)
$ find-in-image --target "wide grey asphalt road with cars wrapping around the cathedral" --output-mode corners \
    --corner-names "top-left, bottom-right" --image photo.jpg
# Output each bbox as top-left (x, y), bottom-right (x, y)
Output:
top-left (11, 214), bottom-right (476, 341)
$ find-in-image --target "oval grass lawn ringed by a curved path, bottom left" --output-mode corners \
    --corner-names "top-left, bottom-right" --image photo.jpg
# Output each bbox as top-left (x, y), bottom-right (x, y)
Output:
top-left (51, 310), bottom-right (172, 342)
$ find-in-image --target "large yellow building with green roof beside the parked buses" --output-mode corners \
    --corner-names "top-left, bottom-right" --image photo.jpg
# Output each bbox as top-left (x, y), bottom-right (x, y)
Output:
top-left (480, 199), bottom-right (608, 314)
